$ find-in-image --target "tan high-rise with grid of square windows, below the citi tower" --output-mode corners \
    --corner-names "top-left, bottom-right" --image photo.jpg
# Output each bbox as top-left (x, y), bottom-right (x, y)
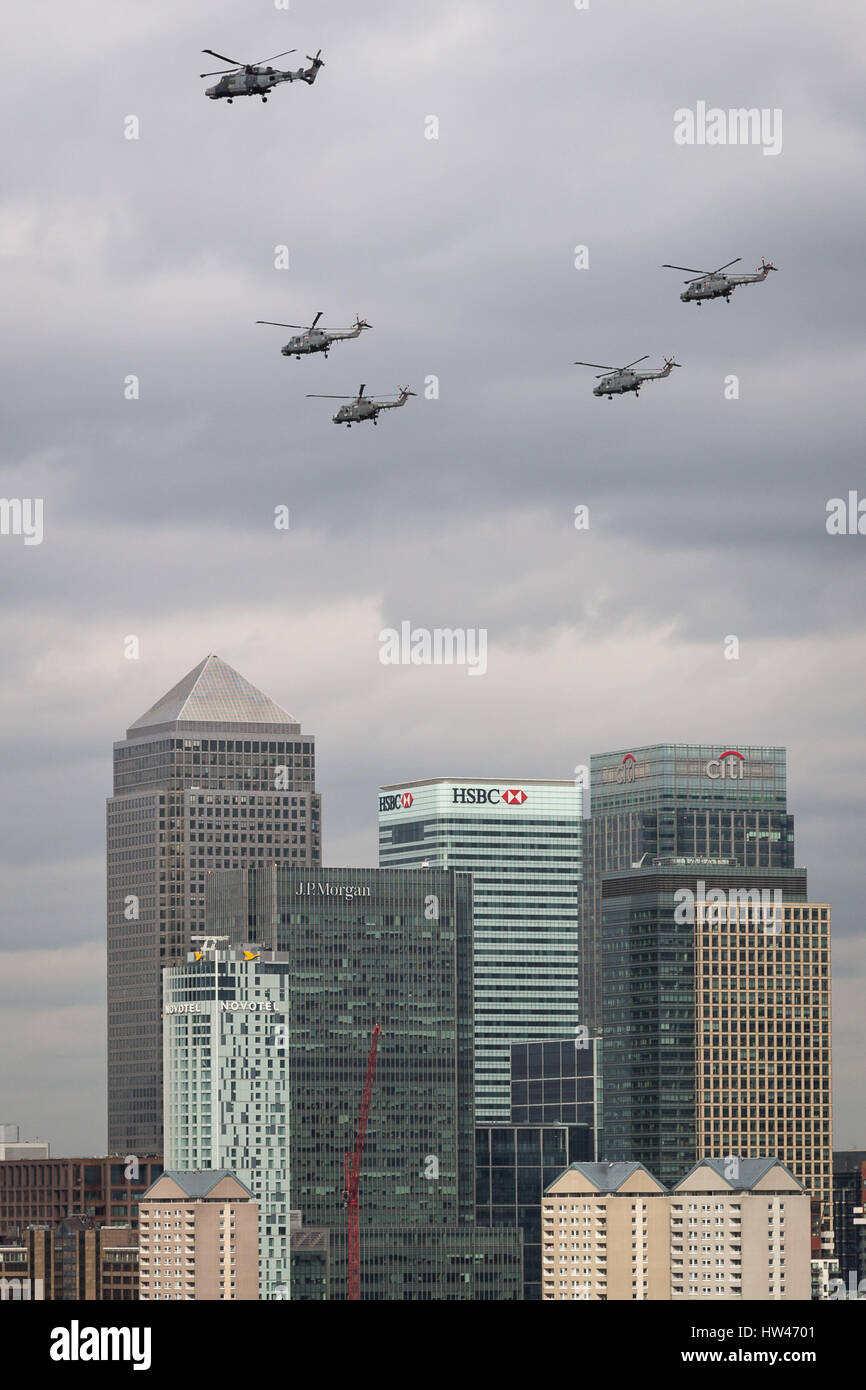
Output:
top-left (695, 895), bottom-right (833, 1234)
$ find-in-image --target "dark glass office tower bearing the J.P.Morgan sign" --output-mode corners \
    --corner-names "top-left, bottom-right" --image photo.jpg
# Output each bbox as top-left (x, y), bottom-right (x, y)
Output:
top-left (209, 865), bottom-right (523, 1300)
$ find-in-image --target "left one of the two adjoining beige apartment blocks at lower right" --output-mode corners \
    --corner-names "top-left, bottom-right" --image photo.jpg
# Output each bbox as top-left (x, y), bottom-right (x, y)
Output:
top-left (541, 1163), bottom-right (670, 1302)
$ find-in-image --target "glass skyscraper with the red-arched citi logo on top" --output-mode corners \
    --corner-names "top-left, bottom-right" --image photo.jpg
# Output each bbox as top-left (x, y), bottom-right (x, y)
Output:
top-left (580, 744), bottom-right (794, 1034)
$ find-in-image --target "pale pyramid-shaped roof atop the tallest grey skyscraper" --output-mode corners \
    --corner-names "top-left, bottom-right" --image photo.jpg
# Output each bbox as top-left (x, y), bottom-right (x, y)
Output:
top-left (126, 653), bottom-right (300, 738)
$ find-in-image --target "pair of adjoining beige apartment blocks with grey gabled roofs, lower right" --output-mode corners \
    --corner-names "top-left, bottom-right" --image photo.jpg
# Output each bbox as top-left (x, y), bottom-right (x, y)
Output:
top-left (542, 1158), bottom-right (810, 1302)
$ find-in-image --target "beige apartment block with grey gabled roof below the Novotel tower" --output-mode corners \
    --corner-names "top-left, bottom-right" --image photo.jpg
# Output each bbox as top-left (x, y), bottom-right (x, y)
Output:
top-left (139, 1169), bottom-right (259, 1302)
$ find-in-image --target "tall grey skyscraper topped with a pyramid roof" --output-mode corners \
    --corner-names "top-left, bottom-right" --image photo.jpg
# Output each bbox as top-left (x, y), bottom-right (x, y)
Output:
top-left (107, 655), bottom-right (321, 1155)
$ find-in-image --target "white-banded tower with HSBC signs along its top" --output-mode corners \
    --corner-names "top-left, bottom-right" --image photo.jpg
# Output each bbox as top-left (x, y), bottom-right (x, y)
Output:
top-left (379, 777), bottom-right (584, 1125)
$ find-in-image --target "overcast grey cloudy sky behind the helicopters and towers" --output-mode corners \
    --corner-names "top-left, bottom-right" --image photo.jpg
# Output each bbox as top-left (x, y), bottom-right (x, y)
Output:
top-left (0, 0), bottom-right (866, 1154)
